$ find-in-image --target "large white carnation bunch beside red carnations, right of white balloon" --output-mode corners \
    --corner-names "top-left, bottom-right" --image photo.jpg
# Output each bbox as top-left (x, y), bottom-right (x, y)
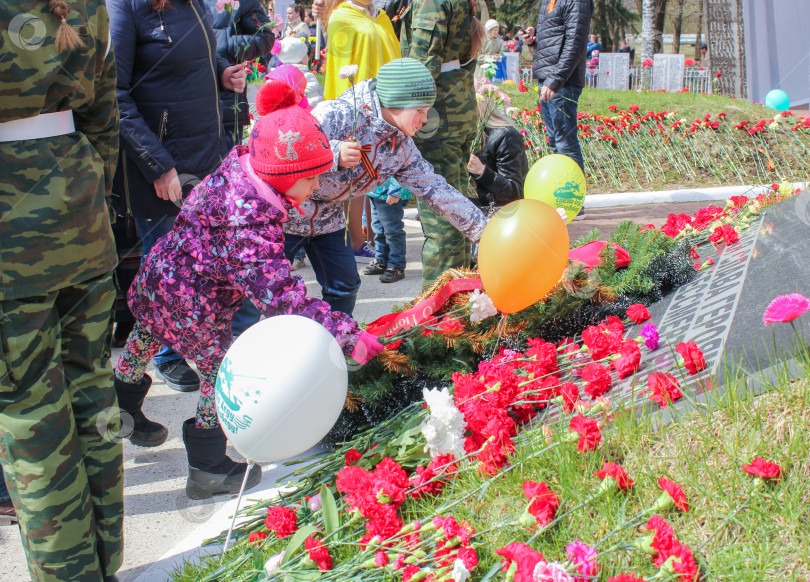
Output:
top-left (420, 388), bottom-right (467, 459)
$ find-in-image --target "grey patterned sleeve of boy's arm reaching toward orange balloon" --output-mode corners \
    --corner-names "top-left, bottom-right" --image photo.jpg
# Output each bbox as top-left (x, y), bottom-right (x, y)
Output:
top-left (394, 139), bottom-right (487, 242)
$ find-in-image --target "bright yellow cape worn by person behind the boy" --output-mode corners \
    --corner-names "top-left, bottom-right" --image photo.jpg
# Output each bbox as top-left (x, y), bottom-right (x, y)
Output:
top-left (323, 2), bottom-right (402, 99)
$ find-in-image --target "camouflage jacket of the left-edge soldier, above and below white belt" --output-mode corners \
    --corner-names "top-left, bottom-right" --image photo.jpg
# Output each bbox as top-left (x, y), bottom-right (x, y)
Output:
top-left (0, 0), bottom-right (118, 300)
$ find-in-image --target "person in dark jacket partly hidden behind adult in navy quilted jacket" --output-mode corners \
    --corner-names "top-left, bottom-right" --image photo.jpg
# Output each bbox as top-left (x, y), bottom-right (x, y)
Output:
top-left (205, 0), bottom-right (276, 149)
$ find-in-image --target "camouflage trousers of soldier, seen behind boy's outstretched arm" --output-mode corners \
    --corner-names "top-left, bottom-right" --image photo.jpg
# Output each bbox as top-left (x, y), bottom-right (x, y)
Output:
top-left (416, 135), bottom-right (473, 289)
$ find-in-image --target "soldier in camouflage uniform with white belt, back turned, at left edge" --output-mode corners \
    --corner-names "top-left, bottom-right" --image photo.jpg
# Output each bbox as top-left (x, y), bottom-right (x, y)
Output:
top-left (0, 0), bottom-right (123, 582)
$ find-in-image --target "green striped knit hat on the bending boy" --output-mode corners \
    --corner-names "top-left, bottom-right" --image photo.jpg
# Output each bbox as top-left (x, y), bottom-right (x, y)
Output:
top-left (377, 59), bottom-right (436, 109)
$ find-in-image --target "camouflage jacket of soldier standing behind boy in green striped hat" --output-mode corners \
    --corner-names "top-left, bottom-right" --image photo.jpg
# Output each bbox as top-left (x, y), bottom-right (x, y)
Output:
top-left (399, 0), bottom-right (478, 143)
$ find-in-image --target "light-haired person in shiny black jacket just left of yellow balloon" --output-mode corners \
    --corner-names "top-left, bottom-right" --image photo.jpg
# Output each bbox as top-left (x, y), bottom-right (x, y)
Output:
top-left (467, 98), bottom-right (529, 209)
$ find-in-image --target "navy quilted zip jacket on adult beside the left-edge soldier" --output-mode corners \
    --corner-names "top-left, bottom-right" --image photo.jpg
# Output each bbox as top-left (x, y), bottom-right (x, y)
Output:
top-left (107, 0), bottom-right (228, 218)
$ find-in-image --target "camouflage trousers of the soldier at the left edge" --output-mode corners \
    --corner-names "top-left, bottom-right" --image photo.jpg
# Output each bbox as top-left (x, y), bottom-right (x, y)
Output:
top-left (0, 274), bottom-right (124, 582)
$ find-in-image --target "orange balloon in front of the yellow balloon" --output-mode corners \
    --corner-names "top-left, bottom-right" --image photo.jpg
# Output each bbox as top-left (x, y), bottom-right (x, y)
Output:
top-left (478, 199), bottom-right (570, 313)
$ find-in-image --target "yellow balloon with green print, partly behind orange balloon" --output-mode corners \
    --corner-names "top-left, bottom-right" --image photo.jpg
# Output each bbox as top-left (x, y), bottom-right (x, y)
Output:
top-left (523, 154), bottom-right (587, 222)
